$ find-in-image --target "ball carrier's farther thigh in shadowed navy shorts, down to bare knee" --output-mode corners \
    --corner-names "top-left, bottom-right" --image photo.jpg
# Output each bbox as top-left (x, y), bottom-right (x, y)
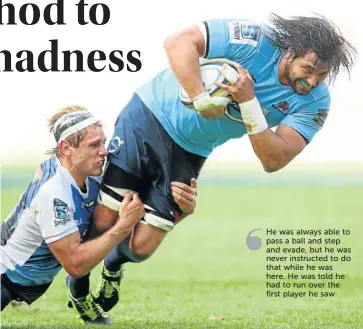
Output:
top-left (129, 141), bottom-right (205, 254)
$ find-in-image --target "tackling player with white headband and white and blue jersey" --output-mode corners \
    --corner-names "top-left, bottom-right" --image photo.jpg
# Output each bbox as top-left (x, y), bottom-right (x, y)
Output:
top-left (0, 106), bottom-right (144, 324)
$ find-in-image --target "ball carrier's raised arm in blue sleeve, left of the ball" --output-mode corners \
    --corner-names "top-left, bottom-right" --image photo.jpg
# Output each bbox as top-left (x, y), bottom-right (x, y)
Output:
top-left (164, 20), bottom-right (261, 119)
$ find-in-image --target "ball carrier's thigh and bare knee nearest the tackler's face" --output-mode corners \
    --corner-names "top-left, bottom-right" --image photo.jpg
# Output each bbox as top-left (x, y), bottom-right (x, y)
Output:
top-left (96, 95), bottom-right (150, 220)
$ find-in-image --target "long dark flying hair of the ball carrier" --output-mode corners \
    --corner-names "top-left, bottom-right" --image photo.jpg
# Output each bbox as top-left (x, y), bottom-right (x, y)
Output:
top-left (264, 14), bottom-right (357, 81)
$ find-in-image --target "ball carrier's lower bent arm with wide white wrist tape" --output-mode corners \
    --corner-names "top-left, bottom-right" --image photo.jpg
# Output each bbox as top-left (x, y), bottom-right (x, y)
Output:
top-left (218, 62), bottom-right (330, 172)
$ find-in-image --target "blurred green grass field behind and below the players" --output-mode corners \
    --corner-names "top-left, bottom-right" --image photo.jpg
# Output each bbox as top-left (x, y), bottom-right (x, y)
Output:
top-left (1, 163), bottom-right (363, 329)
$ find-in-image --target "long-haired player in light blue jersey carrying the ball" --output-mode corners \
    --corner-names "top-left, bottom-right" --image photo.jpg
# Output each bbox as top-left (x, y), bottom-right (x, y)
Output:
top-left (70, 14), bottom-right (355, 318)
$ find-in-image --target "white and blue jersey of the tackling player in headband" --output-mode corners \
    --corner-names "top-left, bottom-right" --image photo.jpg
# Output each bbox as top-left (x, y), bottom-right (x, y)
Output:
top-left (0, 158), bottom-right (99, 286)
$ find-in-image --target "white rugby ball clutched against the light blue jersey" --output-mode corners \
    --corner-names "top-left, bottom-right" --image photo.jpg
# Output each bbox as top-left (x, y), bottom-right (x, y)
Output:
top-left (179, 58), bottom-right (237, 109)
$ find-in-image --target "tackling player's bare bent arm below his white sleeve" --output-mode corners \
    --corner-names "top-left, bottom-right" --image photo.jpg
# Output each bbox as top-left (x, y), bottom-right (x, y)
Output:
top-left (46, 193), bottom-right (145, 277)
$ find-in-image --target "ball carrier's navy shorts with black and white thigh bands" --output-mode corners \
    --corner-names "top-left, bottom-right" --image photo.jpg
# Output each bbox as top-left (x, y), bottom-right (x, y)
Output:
top-left (100, 96), bottom-right (205, 232)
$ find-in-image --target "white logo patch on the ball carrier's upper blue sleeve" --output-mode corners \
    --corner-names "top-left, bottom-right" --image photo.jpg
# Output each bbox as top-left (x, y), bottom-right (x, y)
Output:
top-left (228, 21), bottom-right (261, 47)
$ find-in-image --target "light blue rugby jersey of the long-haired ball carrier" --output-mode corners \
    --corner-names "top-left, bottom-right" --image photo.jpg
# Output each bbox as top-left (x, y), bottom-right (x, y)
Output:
top-left (136, 20), bottom-right (330, 157)
